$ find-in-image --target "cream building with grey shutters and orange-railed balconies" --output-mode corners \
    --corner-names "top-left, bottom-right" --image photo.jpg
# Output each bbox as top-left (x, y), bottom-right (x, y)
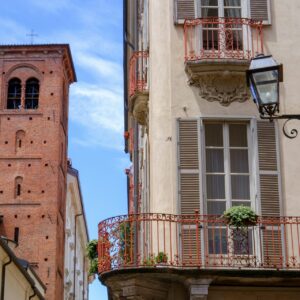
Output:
top-left (99, 0), bottom-right (300, 300)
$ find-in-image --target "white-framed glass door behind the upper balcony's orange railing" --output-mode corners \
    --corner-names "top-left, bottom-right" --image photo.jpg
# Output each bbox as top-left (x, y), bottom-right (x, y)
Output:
top-left (197, 0), bottom-right (250, 58)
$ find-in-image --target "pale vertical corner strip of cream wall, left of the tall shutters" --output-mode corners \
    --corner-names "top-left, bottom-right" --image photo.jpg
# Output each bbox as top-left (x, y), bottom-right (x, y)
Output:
top-left (149, 1), bottom-right (176, 213)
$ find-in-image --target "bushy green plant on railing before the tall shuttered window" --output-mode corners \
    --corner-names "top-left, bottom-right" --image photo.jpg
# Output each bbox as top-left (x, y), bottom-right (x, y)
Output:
top-left (222, 205), bottom-right (258, 228)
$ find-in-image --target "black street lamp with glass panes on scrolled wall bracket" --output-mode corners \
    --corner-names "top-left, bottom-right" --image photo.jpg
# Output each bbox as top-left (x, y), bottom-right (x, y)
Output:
top-left (246, 54), bottom-right (300, 138)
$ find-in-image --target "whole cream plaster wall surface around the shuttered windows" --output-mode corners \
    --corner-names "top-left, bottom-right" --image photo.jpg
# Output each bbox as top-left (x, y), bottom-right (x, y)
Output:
top-left (149, 0), bottom-right (300, 215)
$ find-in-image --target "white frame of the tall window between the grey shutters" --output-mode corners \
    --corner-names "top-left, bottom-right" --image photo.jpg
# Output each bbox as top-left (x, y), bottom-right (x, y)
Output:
top-left (199, 117), bottom-right (261, 263)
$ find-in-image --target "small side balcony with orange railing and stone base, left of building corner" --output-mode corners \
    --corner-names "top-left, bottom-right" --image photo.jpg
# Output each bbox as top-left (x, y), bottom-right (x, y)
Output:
top-left (128, 51), bottom-right (149, 125)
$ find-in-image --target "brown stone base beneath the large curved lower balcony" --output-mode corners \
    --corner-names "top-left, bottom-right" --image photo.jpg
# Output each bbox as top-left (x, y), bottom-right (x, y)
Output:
top-left (100, 268), bottom-right (300, 300)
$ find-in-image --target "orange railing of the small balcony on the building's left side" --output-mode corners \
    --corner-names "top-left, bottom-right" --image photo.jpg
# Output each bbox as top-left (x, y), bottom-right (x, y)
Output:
top-left (129, 51), bottom-right (149, 97)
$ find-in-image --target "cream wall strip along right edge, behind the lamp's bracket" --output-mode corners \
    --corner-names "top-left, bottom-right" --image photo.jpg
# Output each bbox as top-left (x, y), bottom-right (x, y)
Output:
top-left (264, 0), bottom-right (300, 216)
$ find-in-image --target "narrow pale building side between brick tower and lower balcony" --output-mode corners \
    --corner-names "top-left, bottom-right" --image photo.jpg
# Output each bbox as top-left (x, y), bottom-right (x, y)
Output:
top-left (64, 164), bottom-right (89, 300)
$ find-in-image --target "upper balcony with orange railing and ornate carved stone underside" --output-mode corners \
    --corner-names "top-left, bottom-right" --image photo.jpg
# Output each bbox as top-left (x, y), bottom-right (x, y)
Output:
top-left (184, 18), bottom-right (264, 106)
